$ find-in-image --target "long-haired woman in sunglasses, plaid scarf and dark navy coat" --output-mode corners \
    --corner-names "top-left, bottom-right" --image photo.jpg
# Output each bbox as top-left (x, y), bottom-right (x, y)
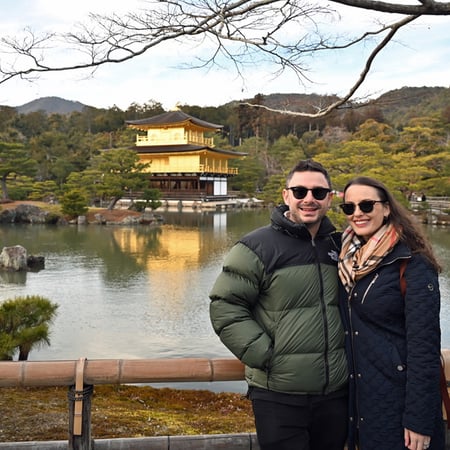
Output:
top-left (339, 177), bottom-right (445, 450)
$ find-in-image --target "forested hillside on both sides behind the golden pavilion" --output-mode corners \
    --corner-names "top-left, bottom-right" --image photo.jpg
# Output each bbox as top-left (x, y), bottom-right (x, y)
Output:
top-left (0, 87), bottom-right (450, 207)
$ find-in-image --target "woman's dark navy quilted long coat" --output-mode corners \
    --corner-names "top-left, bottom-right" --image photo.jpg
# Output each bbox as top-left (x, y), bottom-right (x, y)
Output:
top-left (341, 243), bottom-right (444, 450)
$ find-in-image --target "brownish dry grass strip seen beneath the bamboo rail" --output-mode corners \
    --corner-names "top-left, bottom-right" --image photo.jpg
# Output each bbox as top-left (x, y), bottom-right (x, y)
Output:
top-left (0, 385), bottom-right (255, 442)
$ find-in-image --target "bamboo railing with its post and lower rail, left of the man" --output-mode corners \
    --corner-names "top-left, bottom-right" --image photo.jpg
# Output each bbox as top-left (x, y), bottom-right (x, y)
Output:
top-left (0, 358), bottom-right (251, 450)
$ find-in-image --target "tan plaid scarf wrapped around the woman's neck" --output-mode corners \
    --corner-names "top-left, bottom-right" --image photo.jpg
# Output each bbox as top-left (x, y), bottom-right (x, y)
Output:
top-left (338, 224), bottom-right (400, 292)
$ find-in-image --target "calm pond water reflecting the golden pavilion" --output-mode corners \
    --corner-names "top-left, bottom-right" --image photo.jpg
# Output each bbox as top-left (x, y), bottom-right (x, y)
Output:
top-left (0, 209), bottom-right (450, 390)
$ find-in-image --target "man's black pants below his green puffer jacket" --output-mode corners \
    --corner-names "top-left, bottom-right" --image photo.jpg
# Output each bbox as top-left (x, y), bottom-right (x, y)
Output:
top-left (252, 396), bottom-right (348, 450)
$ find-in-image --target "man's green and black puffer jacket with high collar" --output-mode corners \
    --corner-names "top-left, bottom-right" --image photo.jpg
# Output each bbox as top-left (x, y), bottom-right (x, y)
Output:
top-left (209, 205), bottom-right (347, 394)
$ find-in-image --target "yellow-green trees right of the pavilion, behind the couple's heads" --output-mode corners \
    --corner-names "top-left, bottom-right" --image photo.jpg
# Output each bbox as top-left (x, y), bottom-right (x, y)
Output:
top-left (236, 114), bottom-right (450, 203)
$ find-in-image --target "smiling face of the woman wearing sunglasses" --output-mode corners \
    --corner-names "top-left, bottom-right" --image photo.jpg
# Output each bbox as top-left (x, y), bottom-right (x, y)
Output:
top-left (344, 184), bottom-right (390, 241)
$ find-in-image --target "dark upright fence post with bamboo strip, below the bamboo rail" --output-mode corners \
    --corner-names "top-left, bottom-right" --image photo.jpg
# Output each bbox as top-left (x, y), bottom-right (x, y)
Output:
top-left (67, 384), bottom-right (94, 450)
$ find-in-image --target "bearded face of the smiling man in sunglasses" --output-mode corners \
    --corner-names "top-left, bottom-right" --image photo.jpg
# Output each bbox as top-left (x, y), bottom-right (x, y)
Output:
top-left (283, 171), bottom-right (333, 236)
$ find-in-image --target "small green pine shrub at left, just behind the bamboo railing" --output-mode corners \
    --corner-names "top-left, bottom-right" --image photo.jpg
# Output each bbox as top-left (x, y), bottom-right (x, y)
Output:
top-left (0, 295), bottom-right (58, 361)
